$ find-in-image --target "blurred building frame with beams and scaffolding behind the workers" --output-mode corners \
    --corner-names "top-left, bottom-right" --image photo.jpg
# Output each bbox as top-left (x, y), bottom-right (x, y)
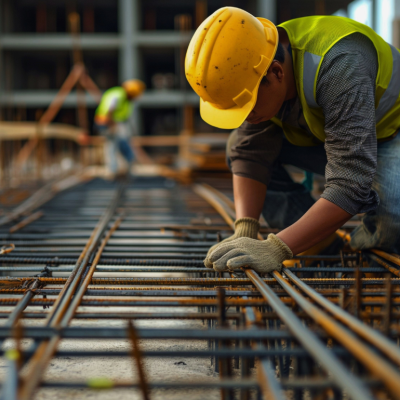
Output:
top-left (0, 0), bottom-right (400, 184)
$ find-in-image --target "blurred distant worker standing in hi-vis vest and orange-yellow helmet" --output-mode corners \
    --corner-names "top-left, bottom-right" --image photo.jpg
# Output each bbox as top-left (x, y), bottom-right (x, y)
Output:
top-left (94, 79), bottom-right (146, 176)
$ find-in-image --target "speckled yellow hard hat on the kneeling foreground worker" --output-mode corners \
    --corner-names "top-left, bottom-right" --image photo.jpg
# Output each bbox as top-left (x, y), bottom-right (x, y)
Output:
top-left (185, 7), bottom-right (278, 129)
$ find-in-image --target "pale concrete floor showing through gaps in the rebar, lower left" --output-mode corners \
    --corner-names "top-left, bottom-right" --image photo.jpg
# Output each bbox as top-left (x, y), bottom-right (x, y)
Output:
top-left (0, 307), bottom-right (225, 400)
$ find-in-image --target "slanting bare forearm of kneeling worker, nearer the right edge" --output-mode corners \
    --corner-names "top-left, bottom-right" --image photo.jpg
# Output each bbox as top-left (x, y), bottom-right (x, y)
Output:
top-left (277, 199), bottom-right (352, 254)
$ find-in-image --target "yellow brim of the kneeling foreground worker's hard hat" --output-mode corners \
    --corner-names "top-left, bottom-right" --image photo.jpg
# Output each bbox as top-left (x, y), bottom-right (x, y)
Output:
top-left (200, 79), bottom-right (261, 129)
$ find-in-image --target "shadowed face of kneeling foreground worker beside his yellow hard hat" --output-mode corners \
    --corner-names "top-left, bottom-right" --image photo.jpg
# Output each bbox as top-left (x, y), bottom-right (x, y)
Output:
top-left (246, 61), bottom-right (287, 124)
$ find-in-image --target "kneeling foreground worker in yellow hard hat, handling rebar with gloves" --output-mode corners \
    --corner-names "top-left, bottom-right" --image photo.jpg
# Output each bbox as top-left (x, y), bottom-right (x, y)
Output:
top-left (185, 7), bottom-right (400, 273)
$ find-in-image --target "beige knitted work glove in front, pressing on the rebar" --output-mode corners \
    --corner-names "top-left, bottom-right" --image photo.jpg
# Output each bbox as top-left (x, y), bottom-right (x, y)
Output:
top-left (208, 233), bottom-right (293, 274)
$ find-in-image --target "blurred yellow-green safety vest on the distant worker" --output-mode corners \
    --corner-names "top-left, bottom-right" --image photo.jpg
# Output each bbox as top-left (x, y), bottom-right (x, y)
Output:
top-left (95, 86), bottom-right (133, 122)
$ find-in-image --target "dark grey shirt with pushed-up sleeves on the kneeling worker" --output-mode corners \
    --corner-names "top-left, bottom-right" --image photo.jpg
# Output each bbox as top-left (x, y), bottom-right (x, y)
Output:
top-left (229, 33), bottom-right (379, 215)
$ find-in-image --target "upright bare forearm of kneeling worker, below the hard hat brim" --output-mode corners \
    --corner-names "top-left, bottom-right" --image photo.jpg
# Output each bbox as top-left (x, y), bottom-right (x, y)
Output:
top-left (233, 175), bottom-right (267, 220)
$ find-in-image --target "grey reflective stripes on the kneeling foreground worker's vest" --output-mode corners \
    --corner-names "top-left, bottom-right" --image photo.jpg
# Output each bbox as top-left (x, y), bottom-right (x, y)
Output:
top-left (303, 45), bottom-right (400, 122)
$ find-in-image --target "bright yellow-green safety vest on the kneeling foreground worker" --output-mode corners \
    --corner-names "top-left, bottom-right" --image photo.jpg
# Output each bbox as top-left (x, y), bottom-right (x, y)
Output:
top-left (272, 16), bottom-right (400, 146)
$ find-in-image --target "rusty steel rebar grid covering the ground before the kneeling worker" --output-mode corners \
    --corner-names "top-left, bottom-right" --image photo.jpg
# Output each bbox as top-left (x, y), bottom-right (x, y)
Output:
top-left (0, 178), bottom-right (400, 400)
